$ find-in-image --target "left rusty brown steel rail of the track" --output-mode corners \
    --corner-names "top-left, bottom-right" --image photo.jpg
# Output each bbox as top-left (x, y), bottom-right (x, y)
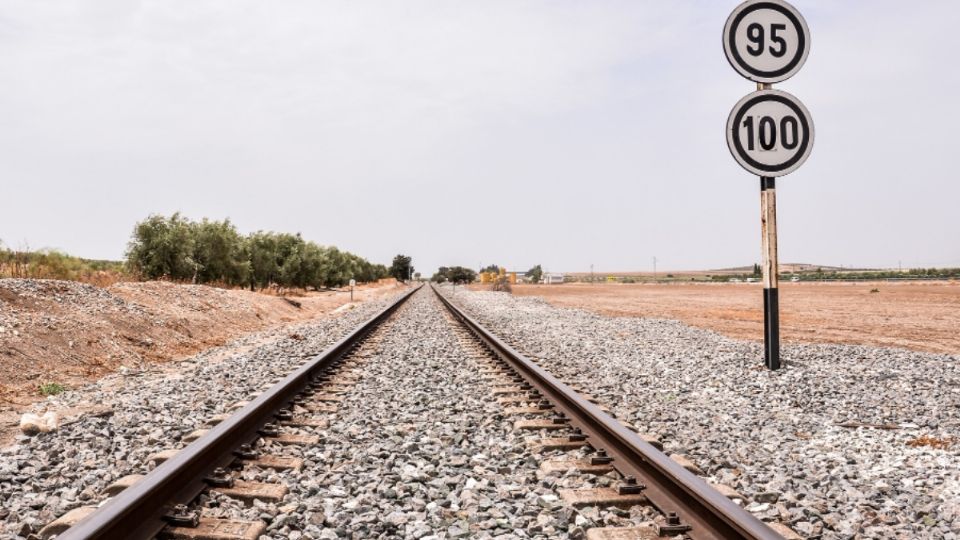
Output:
top-left (57, 285), bottom-right (422, 540)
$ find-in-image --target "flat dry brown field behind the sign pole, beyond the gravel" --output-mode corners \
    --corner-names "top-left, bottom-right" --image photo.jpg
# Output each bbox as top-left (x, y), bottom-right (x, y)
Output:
top-left (513, 281), bottom-right (960, 354)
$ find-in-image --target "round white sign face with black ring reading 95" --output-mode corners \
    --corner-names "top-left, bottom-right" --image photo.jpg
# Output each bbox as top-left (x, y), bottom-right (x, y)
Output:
top-left (723, 0), bottom-right (810, 83)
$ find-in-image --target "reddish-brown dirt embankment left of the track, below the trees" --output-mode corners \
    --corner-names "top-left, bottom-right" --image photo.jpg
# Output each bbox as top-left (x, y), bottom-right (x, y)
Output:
top-left (0, 279), bottom-right (397, 410)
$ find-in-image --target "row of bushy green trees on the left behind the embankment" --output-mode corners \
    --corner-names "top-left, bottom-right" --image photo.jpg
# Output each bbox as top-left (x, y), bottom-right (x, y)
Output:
top-left (126, 212), bottom-right (389, 290)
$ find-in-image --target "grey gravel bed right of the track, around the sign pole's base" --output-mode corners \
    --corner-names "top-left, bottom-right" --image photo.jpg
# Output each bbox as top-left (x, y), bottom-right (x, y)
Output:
top-left (446, 287), bottom-right (960, 539)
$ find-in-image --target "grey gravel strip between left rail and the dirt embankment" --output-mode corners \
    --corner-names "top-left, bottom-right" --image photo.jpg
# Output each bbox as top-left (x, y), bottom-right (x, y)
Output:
top-left (0, 300), bottom-right (406, 538)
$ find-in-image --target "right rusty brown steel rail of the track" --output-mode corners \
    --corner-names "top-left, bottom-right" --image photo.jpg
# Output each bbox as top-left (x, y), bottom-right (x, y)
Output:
top-left (431, 285), bottom-right (783, 540)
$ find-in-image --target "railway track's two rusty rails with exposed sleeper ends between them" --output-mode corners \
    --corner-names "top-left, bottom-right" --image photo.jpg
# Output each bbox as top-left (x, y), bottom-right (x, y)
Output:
top-left (31, 289), bottom-right (796, 539)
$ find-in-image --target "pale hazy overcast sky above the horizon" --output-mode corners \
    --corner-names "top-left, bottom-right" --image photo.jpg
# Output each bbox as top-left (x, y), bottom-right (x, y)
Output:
top-left (0, 0), bottom-right (960, 274)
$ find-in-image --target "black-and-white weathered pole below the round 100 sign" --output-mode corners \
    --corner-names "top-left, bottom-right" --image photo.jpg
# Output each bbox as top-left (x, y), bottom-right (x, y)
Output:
top-left (760, 176), bottom-right (780, 370)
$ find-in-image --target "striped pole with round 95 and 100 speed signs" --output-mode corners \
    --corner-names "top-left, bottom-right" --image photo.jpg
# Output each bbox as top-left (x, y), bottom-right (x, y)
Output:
top-left (723, 0), bottom-right (813, 370)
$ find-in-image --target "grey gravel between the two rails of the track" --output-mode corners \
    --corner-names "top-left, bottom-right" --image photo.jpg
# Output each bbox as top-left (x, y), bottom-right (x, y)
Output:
top-left (204, 289), bottom-right (650, 540)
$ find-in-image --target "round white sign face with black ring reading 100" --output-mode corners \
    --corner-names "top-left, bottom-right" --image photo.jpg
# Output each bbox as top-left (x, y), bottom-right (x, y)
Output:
top-left (727, 90), bottom-right (813, 177)
